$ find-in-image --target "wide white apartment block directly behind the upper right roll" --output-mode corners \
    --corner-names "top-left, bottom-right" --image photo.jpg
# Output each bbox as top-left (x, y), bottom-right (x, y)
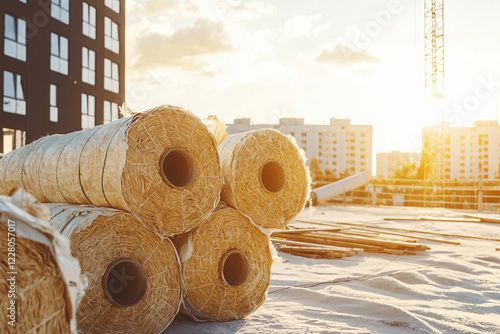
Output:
top-left (227, 118), bottom-right (372, 175)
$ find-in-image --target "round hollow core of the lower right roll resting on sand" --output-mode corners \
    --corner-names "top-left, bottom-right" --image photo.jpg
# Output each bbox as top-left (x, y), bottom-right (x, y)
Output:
top-left (219, 249), bottom-right (250, 287)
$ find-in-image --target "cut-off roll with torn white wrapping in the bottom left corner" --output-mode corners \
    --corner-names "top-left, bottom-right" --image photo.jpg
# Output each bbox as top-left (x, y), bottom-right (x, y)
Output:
top-left (0, 192), bottom-right (85, 333)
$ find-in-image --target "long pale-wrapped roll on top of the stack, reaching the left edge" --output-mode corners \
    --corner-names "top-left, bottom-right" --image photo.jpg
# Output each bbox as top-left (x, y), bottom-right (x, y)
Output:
top-left (0, 106), bottom-right (222, 235)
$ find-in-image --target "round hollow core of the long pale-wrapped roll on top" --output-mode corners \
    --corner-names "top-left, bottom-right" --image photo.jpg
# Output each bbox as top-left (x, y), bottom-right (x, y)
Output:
top-left (160, 147), bottom-right (196, 188)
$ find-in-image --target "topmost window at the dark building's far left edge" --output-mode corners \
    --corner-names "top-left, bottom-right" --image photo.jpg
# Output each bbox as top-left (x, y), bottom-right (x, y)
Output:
top-left (4, 14), bottom-right (26, 61)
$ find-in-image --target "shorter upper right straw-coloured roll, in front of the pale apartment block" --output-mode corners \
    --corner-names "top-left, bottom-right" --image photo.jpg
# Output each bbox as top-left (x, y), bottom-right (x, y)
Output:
top-left (220, 129), bottom-right (310, 228)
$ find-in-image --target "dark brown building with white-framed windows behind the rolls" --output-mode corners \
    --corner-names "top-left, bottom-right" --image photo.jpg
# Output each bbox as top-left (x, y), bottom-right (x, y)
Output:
top-left (0, 0), bottom-right (125, 153)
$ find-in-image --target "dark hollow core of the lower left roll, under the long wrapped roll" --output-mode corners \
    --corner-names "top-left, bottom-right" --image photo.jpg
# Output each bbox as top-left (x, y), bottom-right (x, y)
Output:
top-left (102, 258), bottom-right (148, 307)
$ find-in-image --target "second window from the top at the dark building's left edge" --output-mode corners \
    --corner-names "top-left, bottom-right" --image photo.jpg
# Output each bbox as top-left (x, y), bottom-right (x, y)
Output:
top-left (3, 71), bottom-right (26, 115)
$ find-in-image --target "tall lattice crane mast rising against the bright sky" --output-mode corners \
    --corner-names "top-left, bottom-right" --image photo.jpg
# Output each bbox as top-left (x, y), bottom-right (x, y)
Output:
top-left (424, 0), bottom-right (444, 99)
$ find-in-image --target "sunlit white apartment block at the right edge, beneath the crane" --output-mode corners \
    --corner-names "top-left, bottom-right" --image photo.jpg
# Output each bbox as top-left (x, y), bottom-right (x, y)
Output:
top-left (422, 121), bottom-right (500, 180)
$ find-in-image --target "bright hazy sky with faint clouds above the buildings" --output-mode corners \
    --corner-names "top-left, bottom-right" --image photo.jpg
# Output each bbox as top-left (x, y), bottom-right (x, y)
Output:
top-left (126, 0), bottom-right (500, 159)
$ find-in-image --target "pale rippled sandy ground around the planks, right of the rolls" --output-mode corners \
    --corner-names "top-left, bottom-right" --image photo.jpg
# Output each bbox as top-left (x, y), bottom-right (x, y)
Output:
top-left (164, 206), bottom-right (500, 334)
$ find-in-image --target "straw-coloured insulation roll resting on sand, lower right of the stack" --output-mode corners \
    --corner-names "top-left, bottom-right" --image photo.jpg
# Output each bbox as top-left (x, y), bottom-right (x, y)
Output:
top-left (174, 207), bottom-right (273, 321)
